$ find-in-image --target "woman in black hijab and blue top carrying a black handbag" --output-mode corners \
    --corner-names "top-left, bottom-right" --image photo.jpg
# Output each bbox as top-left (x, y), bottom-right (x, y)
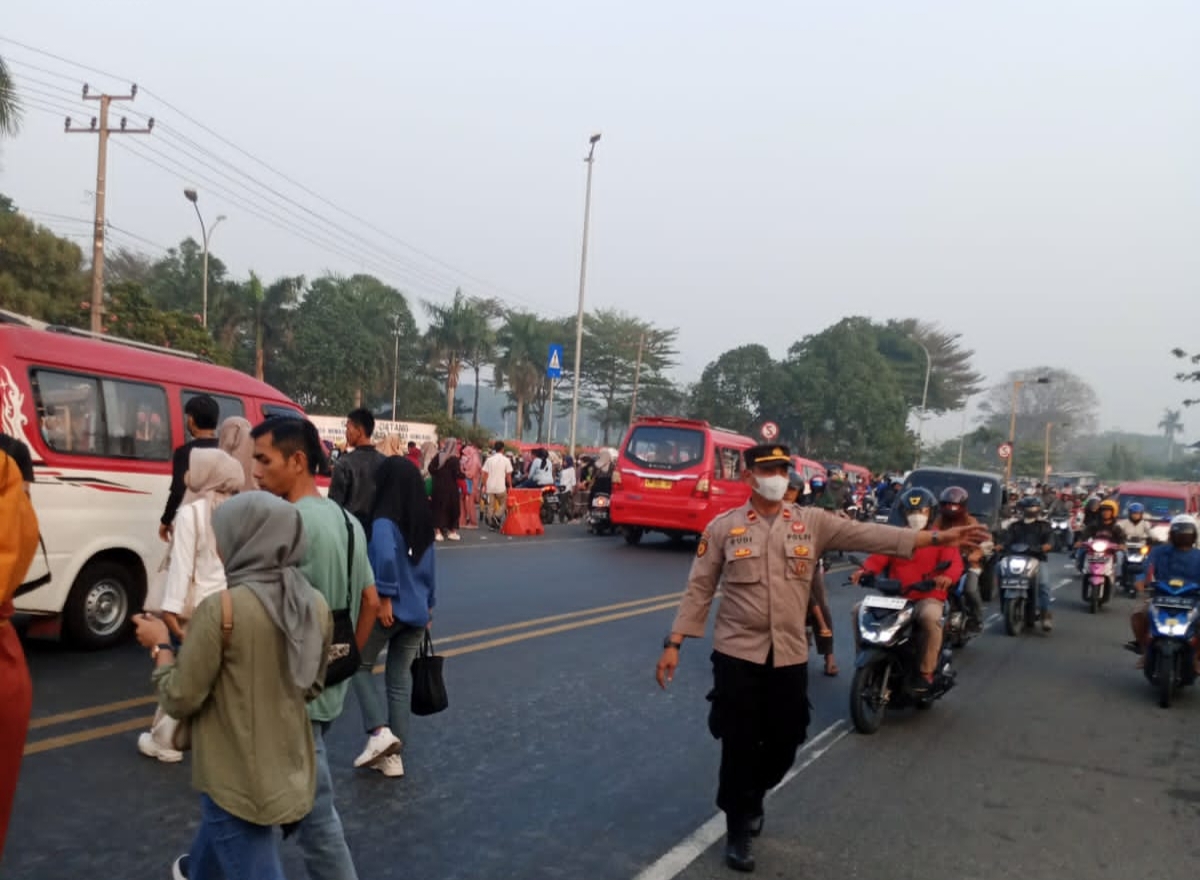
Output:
top-left (354, 457), bottom-right (437, 777)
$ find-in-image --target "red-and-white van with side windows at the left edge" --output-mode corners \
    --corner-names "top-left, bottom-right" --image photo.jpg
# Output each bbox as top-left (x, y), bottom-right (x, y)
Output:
top-left (0, 317), bottom-right (302, 648)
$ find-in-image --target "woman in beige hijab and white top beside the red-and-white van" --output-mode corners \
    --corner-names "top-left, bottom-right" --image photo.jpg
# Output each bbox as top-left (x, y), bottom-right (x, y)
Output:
top-left (138, 446), bottom-right (248, 764)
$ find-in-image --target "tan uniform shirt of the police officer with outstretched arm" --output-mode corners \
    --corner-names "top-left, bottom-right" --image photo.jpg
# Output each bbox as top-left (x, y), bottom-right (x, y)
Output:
top-left (671, 502), bottom-right (917, 666)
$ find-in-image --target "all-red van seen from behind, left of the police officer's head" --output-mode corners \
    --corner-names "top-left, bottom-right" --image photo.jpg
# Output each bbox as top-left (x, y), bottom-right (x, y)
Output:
top-left (612, 417), bottom-right (756, 544)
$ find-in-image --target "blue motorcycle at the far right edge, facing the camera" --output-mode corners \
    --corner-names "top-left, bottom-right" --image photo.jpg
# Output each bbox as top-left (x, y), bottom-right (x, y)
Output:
top-left (1144, 580), bottom-right (1200, 708)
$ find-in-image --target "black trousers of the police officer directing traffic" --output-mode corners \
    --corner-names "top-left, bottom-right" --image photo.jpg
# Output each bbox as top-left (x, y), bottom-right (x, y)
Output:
top-left (708, 651), bottom-right (809, 828)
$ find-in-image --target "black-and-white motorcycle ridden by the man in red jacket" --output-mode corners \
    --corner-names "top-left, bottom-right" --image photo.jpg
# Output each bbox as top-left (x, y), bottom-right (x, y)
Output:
top-left (850, 562), bottom-right (955, 734)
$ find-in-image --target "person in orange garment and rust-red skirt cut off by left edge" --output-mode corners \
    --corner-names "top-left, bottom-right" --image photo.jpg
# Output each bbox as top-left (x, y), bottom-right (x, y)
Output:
top-left (0, 433), bottom-right (37, 858)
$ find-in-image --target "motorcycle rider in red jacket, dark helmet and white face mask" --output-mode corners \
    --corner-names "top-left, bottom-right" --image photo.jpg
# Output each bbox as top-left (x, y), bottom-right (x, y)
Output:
top-left (850, 489), bottom-right (971, 692)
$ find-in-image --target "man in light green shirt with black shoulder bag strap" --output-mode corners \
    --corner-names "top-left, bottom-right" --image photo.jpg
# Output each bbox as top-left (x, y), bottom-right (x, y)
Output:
top-left (251, 417), bottom-right (379, 880)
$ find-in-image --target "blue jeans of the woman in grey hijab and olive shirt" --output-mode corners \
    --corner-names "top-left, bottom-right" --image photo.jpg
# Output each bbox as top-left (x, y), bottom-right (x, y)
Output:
top-left (187, 795), bottom-right (283, 880)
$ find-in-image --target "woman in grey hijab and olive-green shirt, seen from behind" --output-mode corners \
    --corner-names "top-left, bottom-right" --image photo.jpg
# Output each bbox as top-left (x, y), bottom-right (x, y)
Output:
top-left (137, 492), bottom-right (334, 880)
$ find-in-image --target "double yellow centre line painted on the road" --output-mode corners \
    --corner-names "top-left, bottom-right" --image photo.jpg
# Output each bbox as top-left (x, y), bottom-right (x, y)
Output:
top-left (24, 593), bottom-right (679, 755)
